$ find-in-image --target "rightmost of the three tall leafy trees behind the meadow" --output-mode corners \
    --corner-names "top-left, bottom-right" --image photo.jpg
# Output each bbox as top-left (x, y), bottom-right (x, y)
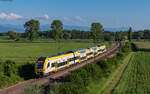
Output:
top-left (91, 23), bottom-right (104, 43)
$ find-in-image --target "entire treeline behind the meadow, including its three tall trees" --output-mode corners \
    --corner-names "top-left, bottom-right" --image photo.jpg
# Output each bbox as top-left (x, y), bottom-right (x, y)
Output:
top-left (0, 19), bottom-right (132, 42)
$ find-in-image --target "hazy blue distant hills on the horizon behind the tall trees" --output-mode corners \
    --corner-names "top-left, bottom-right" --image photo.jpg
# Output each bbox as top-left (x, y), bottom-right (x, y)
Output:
top-left (0, 24), bottom-right (128, 33)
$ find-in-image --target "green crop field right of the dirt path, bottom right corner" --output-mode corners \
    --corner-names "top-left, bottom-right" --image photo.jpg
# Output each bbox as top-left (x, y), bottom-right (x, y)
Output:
top-left (113, 52), bottom-right (150, 94)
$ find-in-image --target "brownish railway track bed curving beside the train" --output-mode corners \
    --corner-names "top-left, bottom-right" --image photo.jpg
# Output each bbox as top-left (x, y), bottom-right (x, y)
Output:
top-left (0, 43), bottom-right (123, 94)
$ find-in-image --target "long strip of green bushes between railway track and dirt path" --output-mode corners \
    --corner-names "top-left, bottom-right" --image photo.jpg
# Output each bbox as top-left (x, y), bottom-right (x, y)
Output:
top-left (23, 43), bottom-right (131, 94)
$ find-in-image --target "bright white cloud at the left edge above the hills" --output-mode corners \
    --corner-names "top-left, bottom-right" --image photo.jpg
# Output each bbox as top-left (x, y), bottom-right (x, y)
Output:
top-left (0, 12), bottom-right (23, 19)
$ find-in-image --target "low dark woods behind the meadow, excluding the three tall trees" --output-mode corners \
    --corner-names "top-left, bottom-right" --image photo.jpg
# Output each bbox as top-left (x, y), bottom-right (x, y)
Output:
top-left (0, 30), bottom-right (128, 41)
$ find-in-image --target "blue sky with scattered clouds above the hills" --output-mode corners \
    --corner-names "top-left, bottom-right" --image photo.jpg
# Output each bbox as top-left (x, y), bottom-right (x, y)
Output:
top-left (0, 0), bottom-right (150, 29)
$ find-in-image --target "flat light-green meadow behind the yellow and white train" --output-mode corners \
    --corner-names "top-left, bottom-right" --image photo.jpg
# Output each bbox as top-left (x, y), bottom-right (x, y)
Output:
top-left (0, 41), bottom-right (113, 63)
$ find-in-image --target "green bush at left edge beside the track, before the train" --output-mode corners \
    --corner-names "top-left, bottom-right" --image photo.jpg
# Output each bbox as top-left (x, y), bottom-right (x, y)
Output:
top-left (0, 60), bottom-right (22, 88)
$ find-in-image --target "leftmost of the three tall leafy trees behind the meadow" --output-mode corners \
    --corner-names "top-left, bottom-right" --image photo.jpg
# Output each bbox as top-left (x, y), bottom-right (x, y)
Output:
top-left (24, 19), bottom-right (40, 41)
